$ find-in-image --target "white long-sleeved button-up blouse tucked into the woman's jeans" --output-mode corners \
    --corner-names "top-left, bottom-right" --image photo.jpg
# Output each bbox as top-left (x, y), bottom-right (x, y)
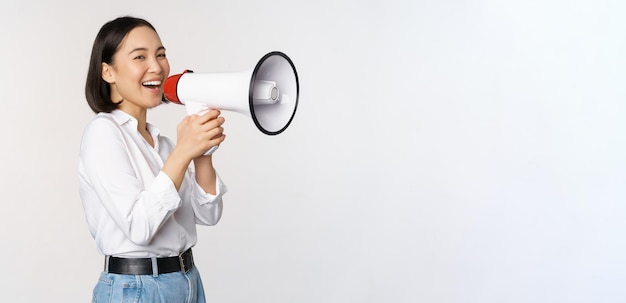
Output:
top-left (78, 110), bottom-right (227, 258)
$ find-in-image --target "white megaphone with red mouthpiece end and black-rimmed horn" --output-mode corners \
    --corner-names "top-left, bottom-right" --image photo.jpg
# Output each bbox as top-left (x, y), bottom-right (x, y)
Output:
top-left (163, 52), bottom-right (300, 154)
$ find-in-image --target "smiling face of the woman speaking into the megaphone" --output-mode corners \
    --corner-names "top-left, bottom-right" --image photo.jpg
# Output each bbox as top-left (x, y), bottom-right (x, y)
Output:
top-left (102, 26), bottom-right (170, 114)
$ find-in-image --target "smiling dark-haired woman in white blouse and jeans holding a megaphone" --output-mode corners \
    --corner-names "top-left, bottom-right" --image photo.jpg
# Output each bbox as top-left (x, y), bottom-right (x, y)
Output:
top-left (79, 17), bottom-right (226, 302)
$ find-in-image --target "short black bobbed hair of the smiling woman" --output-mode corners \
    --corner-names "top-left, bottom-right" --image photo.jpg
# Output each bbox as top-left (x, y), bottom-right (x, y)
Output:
top-left (85, 16), bottom-right (156, 113)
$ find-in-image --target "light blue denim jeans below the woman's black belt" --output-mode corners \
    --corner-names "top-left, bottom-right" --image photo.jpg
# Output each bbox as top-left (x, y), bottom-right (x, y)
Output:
top-left (92, 266), bottom-right (206, 303)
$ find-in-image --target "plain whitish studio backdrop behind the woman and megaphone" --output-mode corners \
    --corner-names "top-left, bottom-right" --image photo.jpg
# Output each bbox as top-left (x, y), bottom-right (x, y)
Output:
top-left (0, 0), bottom-right (626, 303)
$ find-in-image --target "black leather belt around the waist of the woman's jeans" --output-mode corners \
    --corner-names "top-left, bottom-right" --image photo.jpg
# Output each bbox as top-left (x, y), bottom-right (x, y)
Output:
top-left (104, 248), bottom-right (193, 275)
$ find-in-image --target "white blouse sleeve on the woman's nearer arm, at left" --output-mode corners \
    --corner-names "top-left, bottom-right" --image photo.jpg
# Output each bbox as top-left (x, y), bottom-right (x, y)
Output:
top-left (79, 118), bottom-right (181, 245)
